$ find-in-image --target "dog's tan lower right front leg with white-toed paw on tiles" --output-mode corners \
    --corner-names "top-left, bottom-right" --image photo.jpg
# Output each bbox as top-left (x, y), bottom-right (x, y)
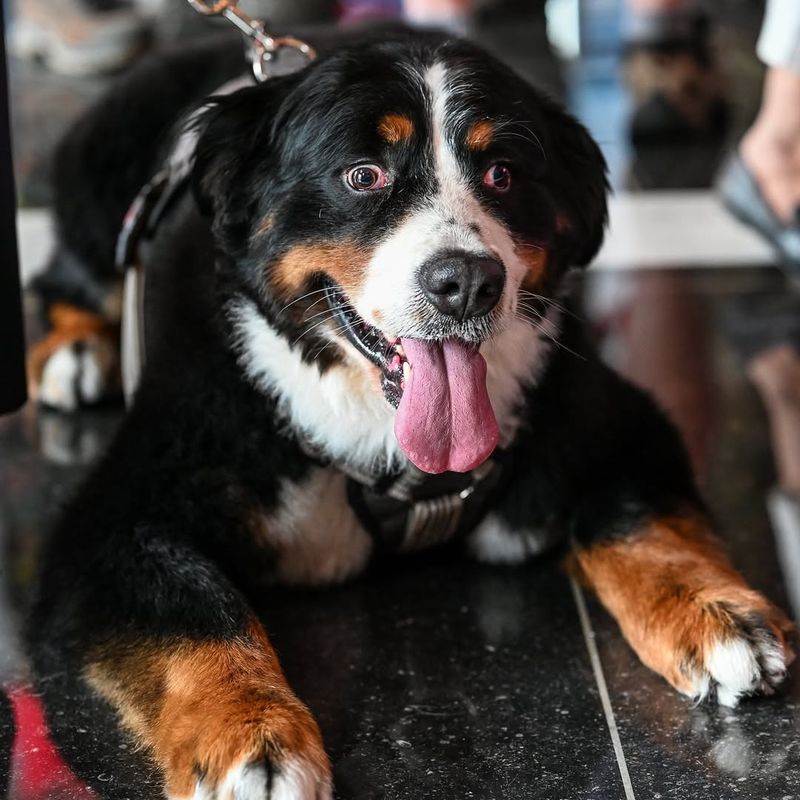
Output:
top-left (575, 516), bottom-right (793, 706)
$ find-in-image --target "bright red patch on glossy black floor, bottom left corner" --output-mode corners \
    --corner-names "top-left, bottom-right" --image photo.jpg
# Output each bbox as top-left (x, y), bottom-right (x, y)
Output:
top-left (6, 686), bottom-right (99, 800)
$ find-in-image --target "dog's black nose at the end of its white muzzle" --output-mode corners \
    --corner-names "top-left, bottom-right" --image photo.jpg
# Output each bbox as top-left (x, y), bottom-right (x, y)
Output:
top-left (419, 252), bottom-right (506, 320)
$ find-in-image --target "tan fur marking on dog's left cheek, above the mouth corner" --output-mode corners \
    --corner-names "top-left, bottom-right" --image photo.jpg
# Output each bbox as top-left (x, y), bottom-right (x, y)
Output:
top-left (271, 242), bottom-right (370, 295)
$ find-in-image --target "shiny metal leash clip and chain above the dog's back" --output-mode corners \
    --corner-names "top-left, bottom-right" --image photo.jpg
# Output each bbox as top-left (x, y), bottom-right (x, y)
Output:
top-left (189, 0), bottom-right (317, 83)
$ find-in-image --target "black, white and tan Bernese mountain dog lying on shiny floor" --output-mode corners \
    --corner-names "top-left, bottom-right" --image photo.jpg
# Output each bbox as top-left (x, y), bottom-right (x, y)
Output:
top-left (30, 26), bottom-right (791, 800)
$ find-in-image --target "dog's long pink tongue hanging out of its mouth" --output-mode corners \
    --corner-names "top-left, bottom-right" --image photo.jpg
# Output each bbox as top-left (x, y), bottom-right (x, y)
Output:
top-left (394, 339), bottom-right (499, 473)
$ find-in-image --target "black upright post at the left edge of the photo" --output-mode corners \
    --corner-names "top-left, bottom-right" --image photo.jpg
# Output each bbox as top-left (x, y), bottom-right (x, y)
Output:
top-left (0, 2), bottom-right (27, 414)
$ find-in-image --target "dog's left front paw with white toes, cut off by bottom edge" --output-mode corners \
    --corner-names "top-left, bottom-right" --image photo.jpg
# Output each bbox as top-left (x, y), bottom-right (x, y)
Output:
top-left (158, 692), bottom-right (332, 800)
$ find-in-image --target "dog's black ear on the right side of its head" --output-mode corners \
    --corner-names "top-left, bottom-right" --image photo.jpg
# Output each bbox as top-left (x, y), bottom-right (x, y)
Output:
top-left (545, 102), bottom-right (608, 267)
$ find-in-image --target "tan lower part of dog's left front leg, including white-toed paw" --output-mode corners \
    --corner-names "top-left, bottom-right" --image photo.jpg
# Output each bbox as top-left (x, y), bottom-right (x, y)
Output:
top-left (85, 620), bottom-right (331, 800)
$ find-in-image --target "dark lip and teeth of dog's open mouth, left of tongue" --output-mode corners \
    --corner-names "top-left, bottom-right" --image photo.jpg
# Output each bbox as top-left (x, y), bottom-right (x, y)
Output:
top-left (325, 283), bottom-right (409, 408)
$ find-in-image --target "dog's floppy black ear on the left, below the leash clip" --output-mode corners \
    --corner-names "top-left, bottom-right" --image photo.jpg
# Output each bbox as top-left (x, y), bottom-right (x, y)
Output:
top-left (191, 81), bottom-right (295, 244)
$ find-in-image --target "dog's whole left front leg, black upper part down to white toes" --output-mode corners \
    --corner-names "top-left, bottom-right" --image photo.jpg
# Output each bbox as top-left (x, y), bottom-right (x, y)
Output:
top-left (29, 524), bottom-right (331, 800)
